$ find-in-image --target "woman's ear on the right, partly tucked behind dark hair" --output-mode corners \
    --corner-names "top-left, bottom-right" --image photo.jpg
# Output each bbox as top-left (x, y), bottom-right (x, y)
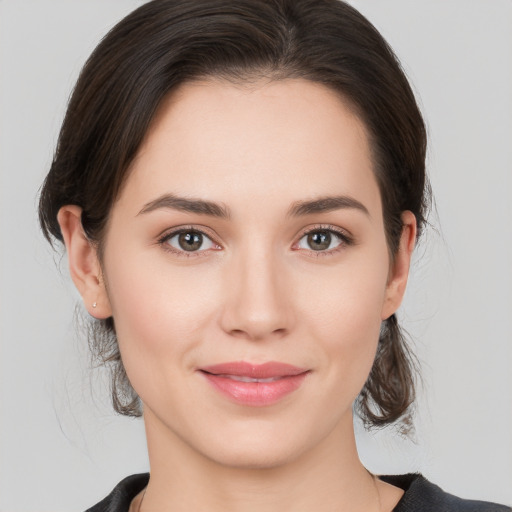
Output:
top-left (382, 211), bottom-right (416, 320)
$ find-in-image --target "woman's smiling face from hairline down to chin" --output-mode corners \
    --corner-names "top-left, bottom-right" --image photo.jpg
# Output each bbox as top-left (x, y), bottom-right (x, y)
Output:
top-left (81, 80), bottom-right (414, 467)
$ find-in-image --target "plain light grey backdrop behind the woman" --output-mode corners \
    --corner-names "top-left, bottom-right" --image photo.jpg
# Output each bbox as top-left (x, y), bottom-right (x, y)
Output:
top-left (0, 0), bottom-right (512, 512)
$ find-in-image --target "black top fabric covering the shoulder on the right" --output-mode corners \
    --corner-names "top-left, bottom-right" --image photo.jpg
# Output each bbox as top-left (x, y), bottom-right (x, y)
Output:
top-left (380, 474), bottom-right (512, 512)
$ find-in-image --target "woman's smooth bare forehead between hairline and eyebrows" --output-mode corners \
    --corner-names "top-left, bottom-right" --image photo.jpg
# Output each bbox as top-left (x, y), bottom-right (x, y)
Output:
top-left (117, 79), bottom-right (380, 216)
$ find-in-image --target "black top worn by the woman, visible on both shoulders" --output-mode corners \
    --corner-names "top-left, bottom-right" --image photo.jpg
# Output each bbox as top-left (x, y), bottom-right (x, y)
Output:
top-left (86, 473), bottom-right (512, 512)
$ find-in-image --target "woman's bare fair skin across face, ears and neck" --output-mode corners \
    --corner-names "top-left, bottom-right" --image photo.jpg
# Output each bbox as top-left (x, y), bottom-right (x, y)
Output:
top-left (58, 80), bottom-right (416, 512)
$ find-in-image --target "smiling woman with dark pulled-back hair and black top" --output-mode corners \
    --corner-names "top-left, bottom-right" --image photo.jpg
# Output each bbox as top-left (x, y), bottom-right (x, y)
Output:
top-left (40, 0), bottom-right (507, 512)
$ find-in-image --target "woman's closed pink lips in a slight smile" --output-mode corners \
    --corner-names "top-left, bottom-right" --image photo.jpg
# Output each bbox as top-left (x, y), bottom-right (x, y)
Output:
top-left (199, 361), bottom-right (309, 406)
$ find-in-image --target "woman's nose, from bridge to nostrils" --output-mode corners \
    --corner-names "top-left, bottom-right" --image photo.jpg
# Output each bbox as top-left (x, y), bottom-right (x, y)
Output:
top-left (220, 246), bottom-right (294, 340)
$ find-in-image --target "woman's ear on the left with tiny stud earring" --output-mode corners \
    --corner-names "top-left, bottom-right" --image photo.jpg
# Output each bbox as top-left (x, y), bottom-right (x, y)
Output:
top-left (57, 205), bottom-right (112, 319)
